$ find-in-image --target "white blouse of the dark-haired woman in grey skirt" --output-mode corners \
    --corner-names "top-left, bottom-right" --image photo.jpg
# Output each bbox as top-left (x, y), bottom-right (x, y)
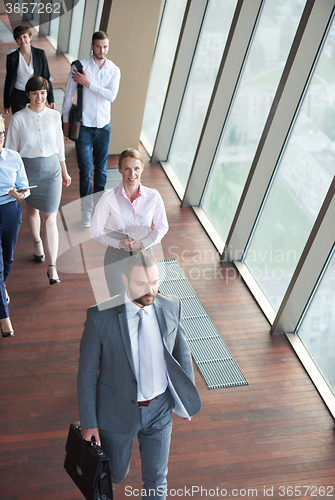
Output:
top-left (6, 104), bottom-right (65, 161)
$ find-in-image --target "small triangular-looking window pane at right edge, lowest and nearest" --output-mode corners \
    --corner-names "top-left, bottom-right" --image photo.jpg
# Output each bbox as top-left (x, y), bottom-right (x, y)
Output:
top-left (297, 250), bottom-right (335, 393)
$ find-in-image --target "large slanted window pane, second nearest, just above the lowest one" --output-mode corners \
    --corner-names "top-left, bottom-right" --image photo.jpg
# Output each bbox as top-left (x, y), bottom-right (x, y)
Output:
top-left (245, 17), bottom-right (335, 310)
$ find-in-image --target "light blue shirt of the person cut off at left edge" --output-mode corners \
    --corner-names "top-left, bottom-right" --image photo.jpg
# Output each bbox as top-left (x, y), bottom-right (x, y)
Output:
top-left (0, 148), bottom-right (30, 205)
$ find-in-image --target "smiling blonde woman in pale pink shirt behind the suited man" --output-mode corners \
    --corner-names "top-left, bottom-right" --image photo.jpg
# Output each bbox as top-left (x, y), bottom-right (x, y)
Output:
top-left (90, 148), bottom-right (169, 296)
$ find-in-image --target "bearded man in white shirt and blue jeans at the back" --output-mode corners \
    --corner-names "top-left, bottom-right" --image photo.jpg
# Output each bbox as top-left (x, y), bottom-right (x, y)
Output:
top-left (62, 31), bottom-right (121, 227)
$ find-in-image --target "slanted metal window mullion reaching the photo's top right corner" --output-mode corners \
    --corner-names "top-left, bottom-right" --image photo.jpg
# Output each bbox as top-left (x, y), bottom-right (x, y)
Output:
top-left (223, 0), bottom-right (333, 261)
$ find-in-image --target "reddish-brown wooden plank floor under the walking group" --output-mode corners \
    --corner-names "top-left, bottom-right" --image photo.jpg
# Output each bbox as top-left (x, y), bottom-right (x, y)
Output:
top-left (0, 17), bottom-right (335, 500)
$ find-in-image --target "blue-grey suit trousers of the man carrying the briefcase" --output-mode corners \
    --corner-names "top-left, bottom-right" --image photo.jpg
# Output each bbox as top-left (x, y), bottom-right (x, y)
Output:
top-left (100, 390), bottom-right (174, 500)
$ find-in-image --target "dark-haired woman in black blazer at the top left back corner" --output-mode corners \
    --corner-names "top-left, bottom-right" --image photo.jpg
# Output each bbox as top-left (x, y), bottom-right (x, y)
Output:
top-left (4, 26), bottom-right (55, 115)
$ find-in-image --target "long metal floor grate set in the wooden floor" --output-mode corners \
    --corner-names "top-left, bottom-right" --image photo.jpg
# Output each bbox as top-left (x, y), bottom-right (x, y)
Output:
top-left (159, 260), bottom-right (248, 389)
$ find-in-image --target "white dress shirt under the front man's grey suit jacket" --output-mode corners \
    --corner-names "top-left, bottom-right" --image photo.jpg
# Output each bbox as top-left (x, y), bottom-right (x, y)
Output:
top-left (125, 292), bottom-right (168, 401)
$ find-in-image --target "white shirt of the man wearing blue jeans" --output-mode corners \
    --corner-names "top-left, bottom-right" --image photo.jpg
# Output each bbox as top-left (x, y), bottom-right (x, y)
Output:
top-left (62, 56), bottom-right (121, 128)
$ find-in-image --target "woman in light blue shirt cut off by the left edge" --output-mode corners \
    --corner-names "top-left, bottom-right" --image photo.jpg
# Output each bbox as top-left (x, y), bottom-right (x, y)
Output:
top-left (0, 115), bottom-right (29, 337)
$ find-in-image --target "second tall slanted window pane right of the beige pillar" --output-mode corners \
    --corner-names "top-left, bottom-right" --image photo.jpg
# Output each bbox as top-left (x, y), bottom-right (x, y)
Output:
top-left (168, 0), bottom-right (237, 188)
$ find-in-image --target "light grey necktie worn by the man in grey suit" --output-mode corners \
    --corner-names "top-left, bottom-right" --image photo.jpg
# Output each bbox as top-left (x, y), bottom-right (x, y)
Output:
top-left (137, 309), bottom-right (154, 399)
